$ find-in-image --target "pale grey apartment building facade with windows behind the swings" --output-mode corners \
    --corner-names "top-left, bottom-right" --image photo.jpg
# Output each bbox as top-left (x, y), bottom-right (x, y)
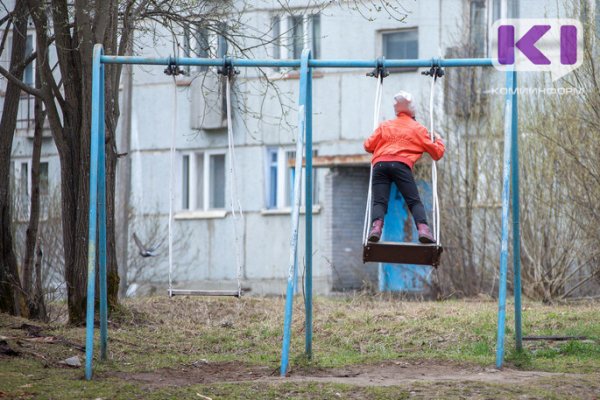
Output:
top-left (0, 0), bottom-right (580, 294)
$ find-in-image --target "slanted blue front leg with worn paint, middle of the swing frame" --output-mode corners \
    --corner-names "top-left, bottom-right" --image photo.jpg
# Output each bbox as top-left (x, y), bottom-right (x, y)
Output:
top-left (279, 48), bottom-right (308, 376)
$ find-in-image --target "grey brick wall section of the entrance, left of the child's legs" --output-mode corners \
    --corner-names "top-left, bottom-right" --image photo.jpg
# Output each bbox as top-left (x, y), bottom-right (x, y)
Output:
top-left (323, 167), bottom-right (377, 291)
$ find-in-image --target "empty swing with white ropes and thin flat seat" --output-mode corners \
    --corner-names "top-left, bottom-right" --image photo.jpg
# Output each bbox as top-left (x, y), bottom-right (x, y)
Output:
top-left (165, 57), bottom-right (244, 298)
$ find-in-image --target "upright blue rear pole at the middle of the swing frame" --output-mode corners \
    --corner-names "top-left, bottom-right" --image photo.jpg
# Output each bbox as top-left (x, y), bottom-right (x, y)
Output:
top-left (302, 49), bottom-right (313, 359)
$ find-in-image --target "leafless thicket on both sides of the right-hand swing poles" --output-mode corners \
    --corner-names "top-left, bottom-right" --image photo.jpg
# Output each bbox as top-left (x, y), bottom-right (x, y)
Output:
top-left (435, 2), bottom-right (600, 302)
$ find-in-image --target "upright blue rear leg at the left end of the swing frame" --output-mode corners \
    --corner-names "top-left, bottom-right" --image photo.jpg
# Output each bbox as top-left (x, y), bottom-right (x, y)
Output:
top-left (98, 60), bottom-right (108, 360)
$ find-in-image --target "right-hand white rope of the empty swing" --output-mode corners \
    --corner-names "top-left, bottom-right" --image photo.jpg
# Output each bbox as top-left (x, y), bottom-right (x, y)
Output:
top-left (225, 74), bottom-right (244, 297)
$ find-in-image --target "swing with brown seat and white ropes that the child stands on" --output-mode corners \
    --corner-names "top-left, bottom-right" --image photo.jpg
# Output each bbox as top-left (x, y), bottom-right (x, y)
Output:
top-left (363, 67), bottom-right (443, 267)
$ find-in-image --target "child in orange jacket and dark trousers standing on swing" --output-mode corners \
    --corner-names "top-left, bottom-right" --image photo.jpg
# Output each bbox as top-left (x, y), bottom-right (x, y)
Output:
top-left (364, 91), bottom-right (445, 243)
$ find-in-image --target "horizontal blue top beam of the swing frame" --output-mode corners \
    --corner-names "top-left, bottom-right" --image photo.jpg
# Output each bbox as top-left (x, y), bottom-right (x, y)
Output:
top-left (100, 55), bottom-right (494, 68)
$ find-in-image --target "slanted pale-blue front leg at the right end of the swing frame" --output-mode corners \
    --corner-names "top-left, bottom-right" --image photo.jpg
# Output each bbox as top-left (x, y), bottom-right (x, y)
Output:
top-left (496, 71), bottom-right (514, 368)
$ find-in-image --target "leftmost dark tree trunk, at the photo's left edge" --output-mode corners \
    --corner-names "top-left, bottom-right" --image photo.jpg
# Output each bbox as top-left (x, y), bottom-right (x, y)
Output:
top-left (0, 1), bottom-right (27, 316)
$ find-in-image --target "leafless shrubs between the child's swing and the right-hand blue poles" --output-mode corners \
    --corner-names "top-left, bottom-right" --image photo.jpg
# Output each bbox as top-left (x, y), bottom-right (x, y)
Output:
top-left (423, 37), bottom-right (502, 297)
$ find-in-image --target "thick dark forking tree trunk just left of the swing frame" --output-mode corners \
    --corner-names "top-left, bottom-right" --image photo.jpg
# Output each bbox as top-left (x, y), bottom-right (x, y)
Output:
top-left (29, 0), bottom-right (86, 325)
